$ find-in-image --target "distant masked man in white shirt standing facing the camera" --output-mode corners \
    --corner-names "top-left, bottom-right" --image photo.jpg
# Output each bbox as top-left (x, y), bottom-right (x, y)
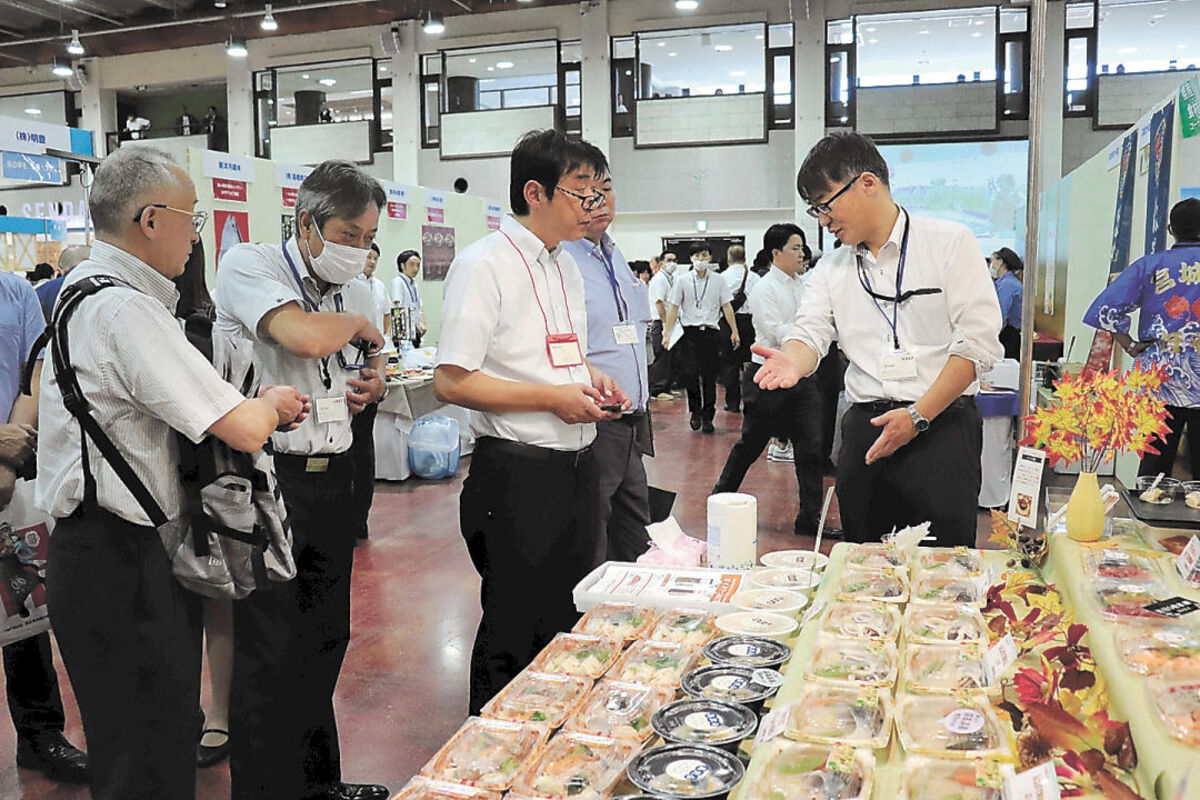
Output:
top-left (662, 243), bottom-right (742, 433)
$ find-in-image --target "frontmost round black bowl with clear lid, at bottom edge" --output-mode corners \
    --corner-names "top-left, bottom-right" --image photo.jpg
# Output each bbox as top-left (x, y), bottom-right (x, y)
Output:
top-left (629, 745), bottom-right (745, 800)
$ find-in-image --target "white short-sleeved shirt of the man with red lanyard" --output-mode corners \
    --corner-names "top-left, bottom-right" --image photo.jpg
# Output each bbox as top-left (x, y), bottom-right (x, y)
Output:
top-left (436, 216), bottom-right (595, 450)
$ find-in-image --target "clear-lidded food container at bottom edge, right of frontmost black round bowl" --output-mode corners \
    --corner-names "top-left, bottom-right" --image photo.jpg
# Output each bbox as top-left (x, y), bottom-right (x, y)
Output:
top-left (739, 739), bottom-right (875, 800)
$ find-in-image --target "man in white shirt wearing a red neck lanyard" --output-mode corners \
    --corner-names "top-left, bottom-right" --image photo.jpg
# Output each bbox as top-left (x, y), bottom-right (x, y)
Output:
top-left (433, 131), bottom-right (630, 714)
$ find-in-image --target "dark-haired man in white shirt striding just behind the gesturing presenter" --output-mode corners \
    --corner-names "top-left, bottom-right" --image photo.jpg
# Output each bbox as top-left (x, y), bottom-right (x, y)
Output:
top-left (713, 223), bottom-right (821, 536)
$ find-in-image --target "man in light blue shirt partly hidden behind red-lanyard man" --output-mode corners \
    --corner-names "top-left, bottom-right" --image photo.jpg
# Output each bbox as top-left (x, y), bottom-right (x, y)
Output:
top-left (563, 145), bottom-right (654, 561)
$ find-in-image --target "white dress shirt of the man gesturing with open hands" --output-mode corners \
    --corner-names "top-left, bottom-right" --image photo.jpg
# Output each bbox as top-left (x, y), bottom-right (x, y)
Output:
top-left (785, 211), bottom-right (1003, 403)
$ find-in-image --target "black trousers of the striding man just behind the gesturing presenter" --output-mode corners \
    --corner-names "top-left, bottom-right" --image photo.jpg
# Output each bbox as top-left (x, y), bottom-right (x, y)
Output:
top-left (713, 371), bottom-right (821, 536)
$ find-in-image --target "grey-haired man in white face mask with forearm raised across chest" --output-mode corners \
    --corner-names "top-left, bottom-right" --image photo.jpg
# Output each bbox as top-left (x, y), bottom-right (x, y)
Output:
top-left (215, 161), bottom-right (388, 800)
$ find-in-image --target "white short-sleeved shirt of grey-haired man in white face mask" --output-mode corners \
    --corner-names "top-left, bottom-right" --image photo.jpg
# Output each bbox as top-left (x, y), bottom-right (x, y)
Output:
top-left (212, 236), bottom-right (380, 456)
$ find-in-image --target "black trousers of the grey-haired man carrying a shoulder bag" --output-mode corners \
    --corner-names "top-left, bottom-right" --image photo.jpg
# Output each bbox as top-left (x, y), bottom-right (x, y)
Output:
top-left (46, 510), bottom-right (202, 800)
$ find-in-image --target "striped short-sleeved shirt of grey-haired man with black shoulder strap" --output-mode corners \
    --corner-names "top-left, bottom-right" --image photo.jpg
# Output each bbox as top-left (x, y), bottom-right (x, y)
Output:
top-left (37, 241), bottom-right (245, 525)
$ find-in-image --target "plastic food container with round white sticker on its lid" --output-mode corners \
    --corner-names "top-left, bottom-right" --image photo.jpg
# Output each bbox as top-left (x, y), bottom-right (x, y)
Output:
top-left (896, 692), bottom-right (1010, 758)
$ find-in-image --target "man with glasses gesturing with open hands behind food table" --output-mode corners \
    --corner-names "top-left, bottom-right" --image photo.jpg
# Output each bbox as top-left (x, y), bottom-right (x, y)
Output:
top-left (754, 133), bottom-right (1002, 547)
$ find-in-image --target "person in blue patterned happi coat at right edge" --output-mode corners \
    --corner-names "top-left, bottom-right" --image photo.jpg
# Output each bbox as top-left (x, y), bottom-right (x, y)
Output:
top-left (1084, 198), bottom-right (1200, 477)
